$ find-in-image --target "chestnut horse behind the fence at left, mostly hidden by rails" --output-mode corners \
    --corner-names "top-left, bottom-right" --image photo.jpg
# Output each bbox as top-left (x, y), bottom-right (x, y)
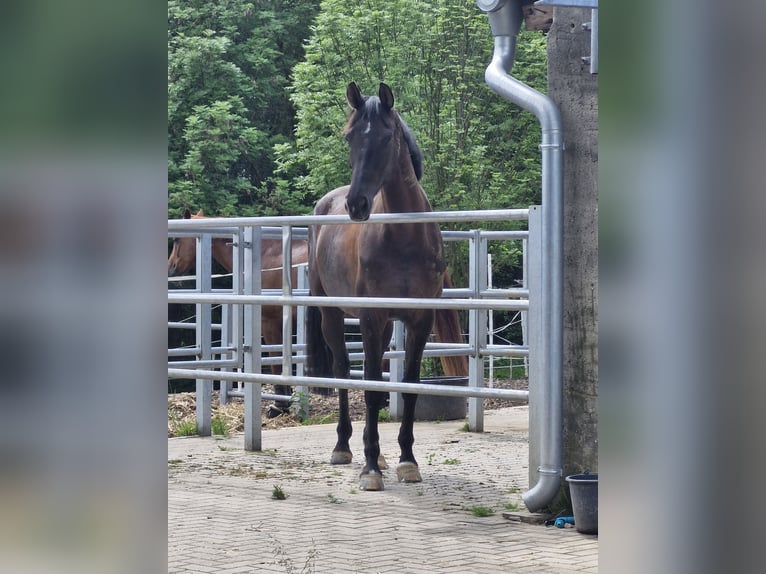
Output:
top-left (168, 209), bottom-right (308, 416)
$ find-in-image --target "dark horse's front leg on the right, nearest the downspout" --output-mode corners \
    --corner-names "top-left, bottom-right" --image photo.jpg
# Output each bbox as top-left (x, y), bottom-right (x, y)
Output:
top-left (396, 311), bottom-right (434, 482)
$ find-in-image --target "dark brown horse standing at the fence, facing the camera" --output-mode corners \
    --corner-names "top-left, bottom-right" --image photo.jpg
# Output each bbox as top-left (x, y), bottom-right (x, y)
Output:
top-left (306, 82), bottom-right (467, 490)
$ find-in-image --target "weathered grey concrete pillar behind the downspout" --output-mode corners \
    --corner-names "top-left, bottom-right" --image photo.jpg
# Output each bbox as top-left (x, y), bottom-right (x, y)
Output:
top-left (548, 8), bottom-right (598, 482)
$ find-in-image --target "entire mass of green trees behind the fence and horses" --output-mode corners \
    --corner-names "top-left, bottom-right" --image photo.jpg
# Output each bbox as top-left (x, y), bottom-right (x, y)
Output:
top-left (168, 0), bottom-right (547, 296)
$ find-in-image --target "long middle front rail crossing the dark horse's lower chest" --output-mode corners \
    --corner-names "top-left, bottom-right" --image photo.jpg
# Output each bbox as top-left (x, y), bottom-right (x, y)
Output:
top-left (168, 291), bottom-right (529, 311)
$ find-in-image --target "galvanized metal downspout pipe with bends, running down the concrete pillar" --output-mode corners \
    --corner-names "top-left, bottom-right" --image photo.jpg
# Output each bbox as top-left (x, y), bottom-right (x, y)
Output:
top-left (476, 0), bottom-right (564, 512)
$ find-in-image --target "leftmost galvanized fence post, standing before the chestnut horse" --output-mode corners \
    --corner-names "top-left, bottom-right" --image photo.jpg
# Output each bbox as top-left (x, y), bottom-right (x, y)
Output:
top-left (195, 233), bottom-right (213, 436)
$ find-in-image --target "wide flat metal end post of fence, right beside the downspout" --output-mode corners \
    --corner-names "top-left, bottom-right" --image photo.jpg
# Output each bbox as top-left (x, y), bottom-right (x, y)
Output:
top-left (524, 205), bottom-right (547, 490)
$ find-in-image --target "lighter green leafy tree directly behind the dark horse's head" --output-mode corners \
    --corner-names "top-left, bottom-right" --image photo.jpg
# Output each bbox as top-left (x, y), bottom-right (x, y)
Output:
top-left (286, 0), bottom-right (546, 284)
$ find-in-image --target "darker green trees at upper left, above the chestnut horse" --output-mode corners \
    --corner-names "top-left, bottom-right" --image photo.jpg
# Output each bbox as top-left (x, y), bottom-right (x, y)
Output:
top-left (168, 0), bottom-right (317, 217)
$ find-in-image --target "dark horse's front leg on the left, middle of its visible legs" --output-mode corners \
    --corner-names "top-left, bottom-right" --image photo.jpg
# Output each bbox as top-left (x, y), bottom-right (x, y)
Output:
top-left (359, 311), bottom-right (392, 490)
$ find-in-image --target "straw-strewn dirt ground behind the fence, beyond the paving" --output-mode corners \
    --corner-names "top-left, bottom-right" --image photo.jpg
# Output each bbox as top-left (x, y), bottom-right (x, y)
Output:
top-left (168, 379), bottom-right (527, 437)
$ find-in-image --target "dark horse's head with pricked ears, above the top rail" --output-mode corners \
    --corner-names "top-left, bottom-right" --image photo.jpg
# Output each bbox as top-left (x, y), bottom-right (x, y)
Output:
top-left (343, 82), bottom-right (402, 221)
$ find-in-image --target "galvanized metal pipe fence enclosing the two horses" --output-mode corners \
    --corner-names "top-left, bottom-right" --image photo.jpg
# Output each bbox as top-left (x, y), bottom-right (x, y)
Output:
top-left (168, 208), bottom-right (542, 450)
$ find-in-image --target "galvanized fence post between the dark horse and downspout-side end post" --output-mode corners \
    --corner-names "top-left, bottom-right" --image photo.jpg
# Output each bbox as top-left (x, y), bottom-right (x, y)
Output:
top-left (468, 229), bottom-right (487, 432)
